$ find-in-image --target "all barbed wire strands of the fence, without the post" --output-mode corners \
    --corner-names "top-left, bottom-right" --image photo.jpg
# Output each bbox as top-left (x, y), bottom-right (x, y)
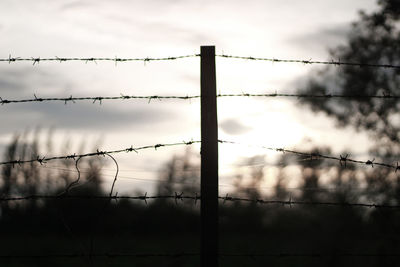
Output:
top-left (0, 49), bottom-right (400, 266)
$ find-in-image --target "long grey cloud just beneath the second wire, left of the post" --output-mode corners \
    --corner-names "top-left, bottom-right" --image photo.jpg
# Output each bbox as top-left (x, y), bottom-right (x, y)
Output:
top-left (0, 102), bottom-right (176, 134)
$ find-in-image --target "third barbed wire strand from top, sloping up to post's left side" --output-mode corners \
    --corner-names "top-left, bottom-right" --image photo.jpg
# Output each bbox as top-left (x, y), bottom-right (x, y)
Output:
top-left (0, 141), bottom-right (200, 166)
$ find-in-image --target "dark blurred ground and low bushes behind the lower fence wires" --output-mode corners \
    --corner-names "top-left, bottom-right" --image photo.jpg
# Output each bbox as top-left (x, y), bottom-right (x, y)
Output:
top-left (0, 138), bottom-right (400, 266)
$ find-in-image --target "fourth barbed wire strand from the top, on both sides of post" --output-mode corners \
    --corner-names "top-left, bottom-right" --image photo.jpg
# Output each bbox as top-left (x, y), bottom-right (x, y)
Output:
top-left (0, 192), bottom-right (400, 210)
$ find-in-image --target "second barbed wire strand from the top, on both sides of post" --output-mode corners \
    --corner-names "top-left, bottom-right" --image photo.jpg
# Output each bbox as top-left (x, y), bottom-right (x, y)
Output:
top-left (0, 92), bottom-right (400, 105)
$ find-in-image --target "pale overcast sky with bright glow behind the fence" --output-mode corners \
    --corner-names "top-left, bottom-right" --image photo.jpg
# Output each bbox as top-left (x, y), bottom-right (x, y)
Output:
top-left (0, 0), bottom-right (376, 196)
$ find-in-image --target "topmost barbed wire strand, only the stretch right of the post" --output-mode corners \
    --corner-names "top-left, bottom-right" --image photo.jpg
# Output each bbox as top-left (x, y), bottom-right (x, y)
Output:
top-left (215, 54), bottom-right (400, 69)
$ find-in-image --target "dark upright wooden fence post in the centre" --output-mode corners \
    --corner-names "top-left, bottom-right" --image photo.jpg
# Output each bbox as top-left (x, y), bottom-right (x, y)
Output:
top-left (200, 46), bottom-right (219, 267)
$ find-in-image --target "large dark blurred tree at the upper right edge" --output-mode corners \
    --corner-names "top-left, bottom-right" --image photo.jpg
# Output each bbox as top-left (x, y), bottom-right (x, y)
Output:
top-left (300, 0), bottom-right (400, 154)
